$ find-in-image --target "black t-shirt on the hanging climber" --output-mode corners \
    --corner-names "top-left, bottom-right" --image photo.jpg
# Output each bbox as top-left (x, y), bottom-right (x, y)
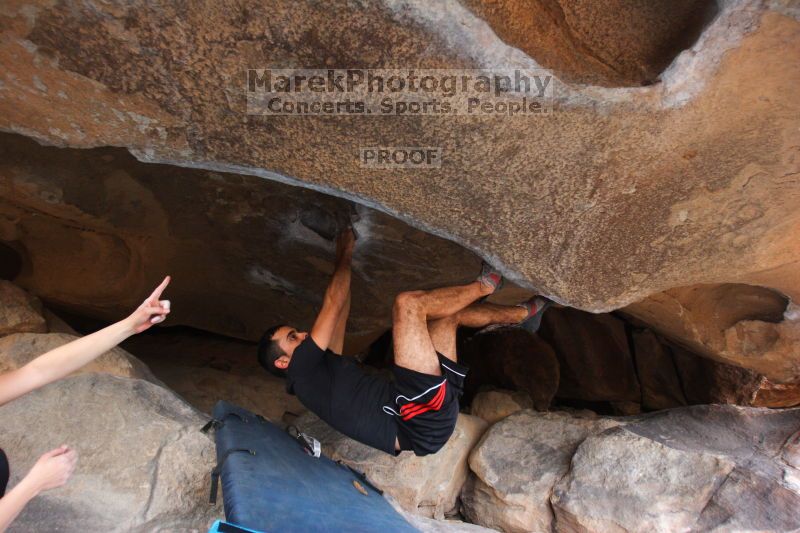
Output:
top-left (286, 335), bottom-right (397, 455)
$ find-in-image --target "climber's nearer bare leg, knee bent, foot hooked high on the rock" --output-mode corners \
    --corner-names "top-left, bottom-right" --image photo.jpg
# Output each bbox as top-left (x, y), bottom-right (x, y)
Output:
top-left (392, 281), bottom-right (494, 376)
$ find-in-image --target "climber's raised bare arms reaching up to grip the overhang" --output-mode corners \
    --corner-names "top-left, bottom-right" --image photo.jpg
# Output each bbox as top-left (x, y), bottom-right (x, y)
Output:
top-left (311, 228), bottom-right (355, 353)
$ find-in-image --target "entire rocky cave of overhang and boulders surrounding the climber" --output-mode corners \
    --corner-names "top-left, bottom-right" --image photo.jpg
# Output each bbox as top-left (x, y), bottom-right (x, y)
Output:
top-left (0, 0), bottom-right (800, 532)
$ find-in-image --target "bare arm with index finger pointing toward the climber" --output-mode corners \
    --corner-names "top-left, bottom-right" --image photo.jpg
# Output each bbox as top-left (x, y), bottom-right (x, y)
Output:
top-left (0, 276), bottom-right (170, 405)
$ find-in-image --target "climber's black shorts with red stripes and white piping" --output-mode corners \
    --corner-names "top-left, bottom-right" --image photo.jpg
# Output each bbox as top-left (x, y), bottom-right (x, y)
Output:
top-left (383, 352), bottom-right (469, 455)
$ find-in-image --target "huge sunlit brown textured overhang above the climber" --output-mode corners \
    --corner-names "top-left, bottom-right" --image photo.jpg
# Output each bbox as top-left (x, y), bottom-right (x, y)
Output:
top-left (0, 0), bottom-right (800, 311)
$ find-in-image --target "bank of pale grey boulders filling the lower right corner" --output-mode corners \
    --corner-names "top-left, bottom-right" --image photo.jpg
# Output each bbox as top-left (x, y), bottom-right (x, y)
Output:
top-left (462, 406), bottom-right (800, 532)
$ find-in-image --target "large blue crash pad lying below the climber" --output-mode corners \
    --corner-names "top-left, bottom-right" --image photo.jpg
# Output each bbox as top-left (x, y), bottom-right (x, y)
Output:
top-left (206, 401), bottom-right (416, 533)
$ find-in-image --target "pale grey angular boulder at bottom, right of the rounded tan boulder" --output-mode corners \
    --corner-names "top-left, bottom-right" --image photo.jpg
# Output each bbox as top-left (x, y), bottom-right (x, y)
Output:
top-left (552, 428), bottom-right (734, 532)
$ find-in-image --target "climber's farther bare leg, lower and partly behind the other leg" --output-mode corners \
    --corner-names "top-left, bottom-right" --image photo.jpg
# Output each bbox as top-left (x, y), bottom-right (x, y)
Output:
top-left (428, 303), bottom-right (528, 361)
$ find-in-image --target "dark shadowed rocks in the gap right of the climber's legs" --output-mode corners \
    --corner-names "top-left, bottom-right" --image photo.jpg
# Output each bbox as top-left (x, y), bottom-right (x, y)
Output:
top-left (459, 304), bottom-right (800, 414)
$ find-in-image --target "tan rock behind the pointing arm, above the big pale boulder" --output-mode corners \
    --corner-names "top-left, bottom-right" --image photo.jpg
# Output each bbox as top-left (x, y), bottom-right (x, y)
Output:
top-left (0, 333), bottom-right (161, 384)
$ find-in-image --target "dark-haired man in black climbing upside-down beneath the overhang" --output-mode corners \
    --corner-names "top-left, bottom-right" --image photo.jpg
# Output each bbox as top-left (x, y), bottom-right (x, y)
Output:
top-left (258, 229), bottom-right (549, 455)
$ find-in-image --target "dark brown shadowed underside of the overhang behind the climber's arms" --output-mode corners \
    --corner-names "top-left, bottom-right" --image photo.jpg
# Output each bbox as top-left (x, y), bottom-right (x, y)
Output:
top-left (0, 134), bottom-right (480, 349)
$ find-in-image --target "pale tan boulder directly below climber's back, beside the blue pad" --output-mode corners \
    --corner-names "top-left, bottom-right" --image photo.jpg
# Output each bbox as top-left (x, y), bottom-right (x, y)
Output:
top-left (295, 413), bottom-right (487, 519)
